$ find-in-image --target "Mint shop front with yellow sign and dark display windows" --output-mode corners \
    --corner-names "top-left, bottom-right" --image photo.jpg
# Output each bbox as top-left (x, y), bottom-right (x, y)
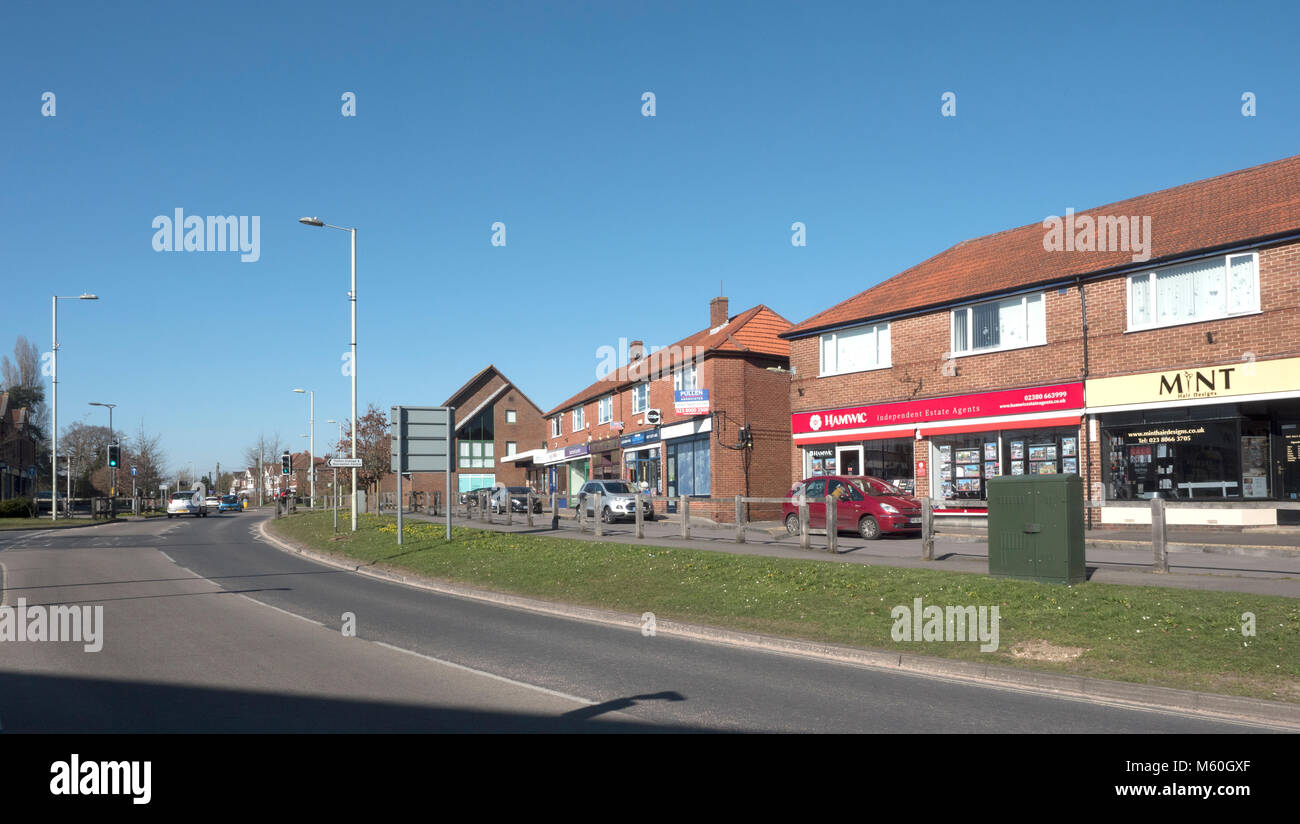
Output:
top-left (1087, 357), bottom-right (1300, 525)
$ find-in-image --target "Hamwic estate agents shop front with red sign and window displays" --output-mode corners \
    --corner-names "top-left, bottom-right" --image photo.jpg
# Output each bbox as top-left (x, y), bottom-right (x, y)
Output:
top-left (792, 383), bottom-right (1084, 513)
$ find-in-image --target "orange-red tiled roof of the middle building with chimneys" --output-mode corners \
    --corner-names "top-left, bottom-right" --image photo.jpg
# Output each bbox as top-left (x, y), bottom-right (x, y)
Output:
top-left (543, 304), bottom-right (790, 417)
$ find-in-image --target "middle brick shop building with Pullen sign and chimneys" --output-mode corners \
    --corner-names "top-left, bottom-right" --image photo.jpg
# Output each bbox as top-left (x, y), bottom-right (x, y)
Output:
top-left (534, 298), bottom-right (790, 520)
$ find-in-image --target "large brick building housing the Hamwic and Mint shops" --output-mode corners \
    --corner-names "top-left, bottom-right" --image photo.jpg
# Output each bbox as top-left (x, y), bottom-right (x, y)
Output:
top-left (783, 156), bottom-right (1300, 525)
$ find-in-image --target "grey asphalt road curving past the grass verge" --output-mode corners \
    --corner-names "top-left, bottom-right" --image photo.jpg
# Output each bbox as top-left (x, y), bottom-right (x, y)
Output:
top-left (0, 512), bottom-right (1279, 733)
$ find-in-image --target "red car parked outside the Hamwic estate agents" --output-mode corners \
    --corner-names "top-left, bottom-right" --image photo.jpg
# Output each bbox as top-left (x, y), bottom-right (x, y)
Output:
top-left (781, 474), bottom-right (920, 541)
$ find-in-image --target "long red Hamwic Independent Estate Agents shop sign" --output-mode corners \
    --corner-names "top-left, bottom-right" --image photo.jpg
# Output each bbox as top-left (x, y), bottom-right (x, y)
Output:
top-left (790, 383), bottom-right (1083, 434)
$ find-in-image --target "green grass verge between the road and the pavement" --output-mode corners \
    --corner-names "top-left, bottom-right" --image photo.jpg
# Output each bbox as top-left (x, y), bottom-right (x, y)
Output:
top-left (269, 512), bottom-right (1300, 703)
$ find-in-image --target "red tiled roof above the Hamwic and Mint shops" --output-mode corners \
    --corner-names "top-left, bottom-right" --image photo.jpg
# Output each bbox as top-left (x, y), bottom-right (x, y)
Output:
top-left (783, 155), bottom-right (1300, 338)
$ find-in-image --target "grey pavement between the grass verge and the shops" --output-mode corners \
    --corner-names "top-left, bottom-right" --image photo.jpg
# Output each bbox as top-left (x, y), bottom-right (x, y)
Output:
top-left (403, 501), bottom-right (1300, 598)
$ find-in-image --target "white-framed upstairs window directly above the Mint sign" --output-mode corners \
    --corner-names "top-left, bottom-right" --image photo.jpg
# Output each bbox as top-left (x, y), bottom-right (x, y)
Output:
top-left (1128, 252), bottom-right (1260, 330)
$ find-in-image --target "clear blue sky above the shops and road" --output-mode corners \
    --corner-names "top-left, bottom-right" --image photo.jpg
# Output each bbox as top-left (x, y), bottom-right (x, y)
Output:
top-left (0, 1), bottom-right (1300, 469)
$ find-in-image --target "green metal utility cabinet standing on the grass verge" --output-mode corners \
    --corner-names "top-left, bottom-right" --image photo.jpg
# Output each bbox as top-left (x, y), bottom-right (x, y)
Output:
top-left (988, 474), bottom-right (1087, 584)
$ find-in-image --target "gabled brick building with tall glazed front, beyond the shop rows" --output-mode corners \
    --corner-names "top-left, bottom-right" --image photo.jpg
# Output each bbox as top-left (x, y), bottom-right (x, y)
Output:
top-left (381, 364), bottom-right (546, 495)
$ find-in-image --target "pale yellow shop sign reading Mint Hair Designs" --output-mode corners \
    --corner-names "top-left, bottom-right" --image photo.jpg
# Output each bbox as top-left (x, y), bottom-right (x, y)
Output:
top-left (1084, 357), bottom-right (1300, 409)
